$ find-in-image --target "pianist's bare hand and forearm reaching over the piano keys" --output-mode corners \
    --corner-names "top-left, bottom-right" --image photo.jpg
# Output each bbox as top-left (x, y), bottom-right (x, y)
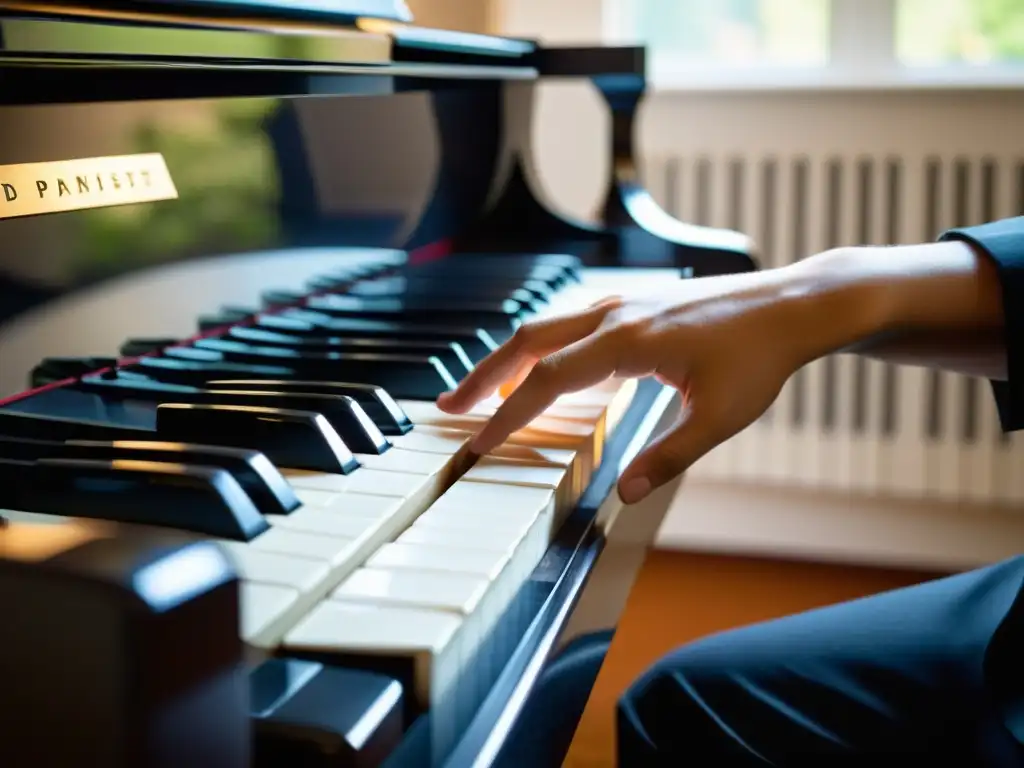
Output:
top-left (438, 241), bottom-right (1008, 504)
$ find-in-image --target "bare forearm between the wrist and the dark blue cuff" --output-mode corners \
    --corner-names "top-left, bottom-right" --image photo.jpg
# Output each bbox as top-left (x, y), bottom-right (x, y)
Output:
top-left (794, 242), bottom-right (1007, 379)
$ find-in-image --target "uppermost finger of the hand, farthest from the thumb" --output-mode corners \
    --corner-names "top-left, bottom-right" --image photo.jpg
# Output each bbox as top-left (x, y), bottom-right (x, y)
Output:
top-left (437, 301), bottom-right (613, 414)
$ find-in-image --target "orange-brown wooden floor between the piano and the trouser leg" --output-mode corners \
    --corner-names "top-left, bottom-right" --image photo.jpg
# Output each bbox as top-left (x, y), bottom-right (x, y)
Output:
top-left (564, 551), bottom-right (940, 768)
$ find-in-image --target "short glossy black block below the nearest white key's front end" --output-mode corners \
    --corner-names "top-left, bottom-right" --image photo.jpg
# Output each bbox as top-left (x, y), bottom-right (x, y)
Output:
top-left (249, 658), bottom-right (404, 768)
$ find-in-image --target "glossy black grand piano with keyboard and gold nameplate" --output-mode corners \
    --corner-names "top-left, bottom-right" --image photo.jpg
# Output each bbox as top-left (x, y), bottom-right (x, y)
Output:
top-left (0, 0), bottom-right (756, 768)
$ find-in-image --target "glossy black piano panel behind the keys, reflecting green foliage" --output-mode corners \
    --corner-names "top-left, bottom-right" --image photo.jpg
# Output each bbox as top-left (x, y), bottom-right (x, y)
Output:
top-left (0, 72), bottom-right (512, 397)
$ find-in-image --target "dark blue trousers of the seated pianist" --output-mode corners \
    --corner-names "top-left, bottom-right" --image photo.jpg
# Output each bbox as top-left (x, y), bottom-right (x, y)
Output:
top-left (517, 557), bottom-right (1024, 768)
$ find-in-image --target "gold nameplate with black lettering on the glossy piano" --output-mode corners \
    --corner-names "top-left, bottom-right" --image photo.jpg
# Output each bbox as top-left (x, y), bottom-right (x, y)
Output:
top-left (0, 153), bottom-right (178, 219)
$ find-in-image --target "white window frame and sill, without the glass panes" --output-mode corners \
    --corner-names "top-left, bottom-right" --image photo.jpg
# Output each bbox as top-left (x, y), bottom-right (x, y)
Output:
top-left (600, 0), bottom-right (1024, 91)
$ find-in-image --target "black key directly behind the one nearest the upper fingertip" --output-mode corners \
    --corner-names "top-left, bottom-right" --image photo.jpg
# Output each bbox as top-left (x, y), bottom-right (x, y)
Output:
top-left (210, 327), bottom-right (473, 378)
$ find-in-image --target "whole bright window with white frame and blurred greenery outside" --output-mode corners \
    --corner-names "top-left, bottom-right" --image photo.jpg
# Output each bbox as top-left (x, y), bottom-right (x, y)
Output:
top-left (602, 0), bottom-right (1024, 86)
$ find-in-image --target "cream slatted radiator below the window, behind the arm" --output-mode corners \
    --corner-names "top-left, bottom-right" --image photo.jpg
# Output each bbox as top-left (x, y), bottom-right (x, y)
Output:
top-left (645, 152), bottom-right (1024, 507)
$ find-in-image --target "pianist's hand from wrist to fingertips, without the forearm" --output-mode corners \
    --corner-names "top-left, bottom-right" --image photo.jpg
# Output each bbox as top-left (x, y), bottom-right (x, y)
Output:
top-left (437, 253), bottom-right (872, 503)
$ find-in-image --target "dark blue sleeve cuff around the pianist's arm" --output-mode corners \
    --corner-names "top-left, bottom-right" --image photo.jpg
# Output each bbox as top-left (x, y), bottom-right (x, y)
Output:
top-left (941, 216), bottom-right (1024, 432)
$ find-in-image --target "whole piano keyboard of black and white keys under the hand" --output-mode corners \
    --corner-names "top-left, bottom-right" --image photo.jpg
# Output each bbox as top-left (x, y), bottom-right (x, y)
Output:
top-left (6, 257), bottom-right (680, 757)
